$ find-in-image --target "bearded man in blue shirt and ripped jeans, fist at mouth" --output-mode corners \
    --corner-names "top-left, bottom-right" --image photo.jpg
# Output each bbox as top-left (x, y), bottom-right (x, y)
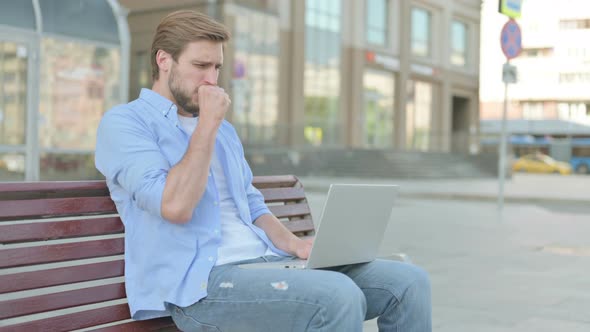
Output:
top-left (96, 11), bottom-right (431, 331)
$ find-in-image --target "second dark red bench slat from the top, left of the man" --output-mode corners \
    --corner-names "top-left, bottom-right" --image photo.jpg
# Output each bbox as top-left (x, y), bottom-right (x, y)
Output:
top-left (0, 196), bottom-right (117, 220)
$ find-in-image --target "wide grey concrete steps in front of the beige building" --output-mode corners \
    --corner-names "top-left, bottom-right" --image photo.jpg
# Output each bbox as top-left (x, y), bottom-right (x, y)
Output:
top-left (246, 149), bottom-right (497, 178)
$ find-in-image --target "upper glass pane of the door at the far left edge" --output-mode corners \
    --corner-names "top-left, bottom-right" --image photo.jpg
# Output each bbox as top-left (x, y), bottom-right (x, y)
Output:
top-left (0, 41), bottom-right (28, 146)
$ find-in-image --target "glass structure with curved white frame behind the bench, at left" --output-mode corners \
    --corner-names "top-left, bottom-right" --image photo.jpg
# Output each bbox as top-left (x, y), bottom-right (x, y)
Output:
top-left (0, 0), bottom-right (130, 181)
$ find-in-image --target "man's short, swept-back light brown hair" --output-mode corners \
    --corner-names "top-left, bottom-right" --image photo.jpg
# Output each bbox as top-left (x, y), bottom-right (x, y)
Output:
top-left (151, 10), bottom-right (230, 81)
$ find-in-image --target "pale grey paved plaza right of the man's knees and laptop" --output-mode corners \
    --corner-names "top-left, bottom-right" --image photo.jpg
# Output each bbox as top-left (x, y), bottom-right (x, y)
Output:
top-left (302, 188), bottom-right (590, 332)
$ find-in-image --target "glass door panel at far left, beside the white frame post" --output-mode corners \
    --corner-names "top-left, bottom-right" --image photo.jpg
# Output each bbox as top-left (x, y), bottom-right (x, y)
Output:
top-left (0, 34), bottom-right (38, 181)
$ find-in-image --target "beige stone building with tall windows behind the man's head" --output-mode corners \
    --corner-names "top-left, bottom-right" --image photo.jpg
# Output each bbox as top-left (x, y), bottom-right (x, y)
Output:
top-left (120, 0), bottom-right (481, 153)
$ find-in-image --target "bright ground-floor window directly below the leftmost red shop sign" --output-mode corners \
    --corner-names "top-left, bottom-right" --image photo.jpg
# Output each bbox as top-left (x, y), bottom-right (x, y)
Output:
top-left (363, 69), bottom-right (395, 148)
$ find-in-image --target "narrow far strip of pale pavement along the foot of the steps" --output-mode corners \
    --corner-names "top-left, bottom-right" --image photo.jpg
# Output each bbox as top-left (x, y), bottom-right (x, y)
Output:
top-left (300, 174), bottom-right (590, 205)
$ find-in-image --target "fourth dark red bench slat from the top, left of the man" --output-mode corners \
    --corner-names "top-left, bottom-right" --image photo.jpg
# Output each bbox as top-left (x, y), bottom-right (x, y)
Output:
top-left (0, 238), bottom-right (125, 268)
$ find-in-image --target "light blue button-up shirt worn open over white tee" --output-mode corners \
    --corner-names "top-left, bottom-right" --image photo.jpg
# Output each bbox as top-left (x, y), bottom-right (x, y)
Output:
top-left (96, 89), bottom-right (287, 319)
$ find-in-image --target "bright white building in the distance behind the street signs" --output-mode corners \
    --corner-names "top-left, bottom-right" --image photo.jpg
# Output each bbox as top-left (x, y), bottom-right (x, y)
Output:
top-left (480, 0), bottom-right (590, 138)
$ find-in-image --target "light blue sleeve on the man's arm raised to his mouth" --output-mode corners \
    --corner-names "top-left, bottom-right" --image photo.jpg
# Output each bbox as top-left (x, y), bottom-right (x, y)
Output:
top-left (95, 106), bottom-right (170, 217)
